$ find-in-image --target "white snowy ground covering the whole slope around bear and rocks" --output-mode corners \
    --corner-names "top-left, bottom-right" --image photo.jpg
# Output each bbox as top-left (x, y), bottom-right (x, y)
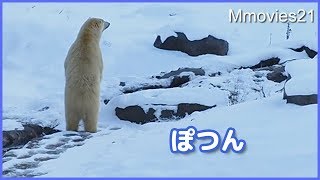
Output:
top-left (2, 3), bottom-right (318, 177)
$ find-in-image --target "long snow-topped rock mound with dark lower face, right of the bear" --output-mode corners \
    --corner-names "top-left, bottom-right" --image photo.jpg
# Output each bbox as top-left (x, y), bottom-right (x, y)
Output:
top-left (106, 68), bottom-right (283, 124)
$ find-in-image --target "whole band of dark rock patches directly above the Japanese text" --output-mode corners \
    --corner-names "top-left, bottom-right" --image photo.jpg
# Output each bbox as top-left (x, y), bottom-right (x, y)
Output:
top-left (115, 103), bottom-right (215, 124)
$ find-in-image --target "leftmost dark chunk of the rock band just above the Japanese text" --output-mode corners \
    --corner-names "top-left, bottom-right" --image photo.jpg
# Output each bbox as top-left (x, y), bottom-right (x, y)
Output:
top-left (115, 105), bottom-right (157, 124)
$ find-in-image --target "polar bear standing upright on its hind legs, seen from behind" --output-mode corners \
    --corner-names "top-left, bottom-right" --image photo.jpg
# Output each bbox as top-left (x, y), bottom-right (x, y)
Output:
top-left (64, 18), bottom-right (110, 132)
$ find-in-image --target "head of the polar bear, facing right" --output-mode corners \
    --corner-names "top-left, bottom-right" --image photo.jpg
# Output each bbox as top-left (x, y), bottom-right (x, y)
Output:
top-left (79, 18), bottom-right (110, 40)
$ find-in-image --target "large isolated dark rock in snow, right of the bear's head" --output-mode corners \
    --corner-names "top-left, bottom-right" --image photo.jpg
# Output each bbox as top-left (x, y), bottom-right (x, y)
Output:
top-left (153, 32), bottom-right (229, 56)
